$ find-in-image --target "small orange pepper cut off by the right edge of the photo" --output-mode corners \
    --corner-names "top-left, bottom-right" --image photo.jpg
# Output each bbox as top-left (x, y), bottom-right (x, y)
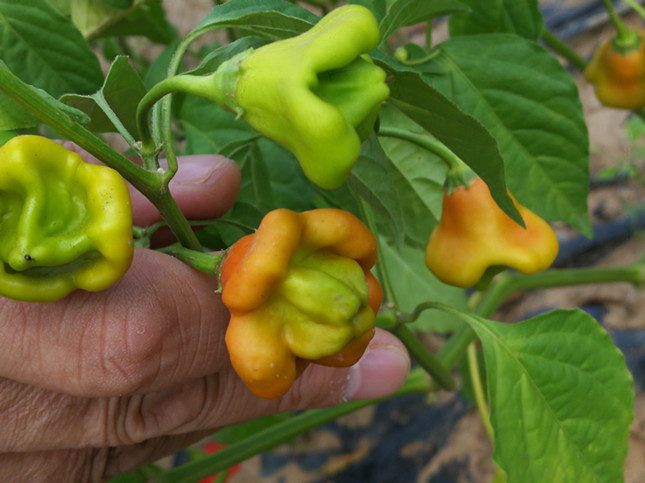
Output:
top-left (584, 32), bottom-right (645, 110)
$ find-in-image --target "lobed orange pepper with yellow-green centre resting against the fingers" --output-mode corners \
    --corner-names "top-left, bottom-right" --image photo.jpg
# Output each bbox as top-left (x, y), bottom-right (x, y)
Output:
top-left (221, 209), bottom-right (383, 399)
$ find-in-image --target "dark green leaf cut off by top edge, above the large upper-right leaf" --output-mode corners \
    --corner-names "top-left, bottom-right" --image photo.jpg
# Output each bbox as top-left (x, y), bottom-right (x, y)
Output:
top-left (448, 0), bottom-right (544, 40)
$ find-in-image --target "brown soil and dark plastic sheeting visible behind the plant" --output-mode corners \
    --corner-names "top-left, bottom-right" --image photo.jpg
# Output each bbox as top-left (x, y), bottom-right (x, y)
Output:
top-left (156, 0), bottom-right (645, 483)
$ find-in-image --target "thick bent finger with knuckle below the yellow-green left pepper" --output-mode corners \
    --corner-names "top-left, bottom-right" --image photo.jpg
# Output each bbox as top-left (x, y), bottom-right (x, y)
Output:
top-left (0, 249), bottom-right (229, 397)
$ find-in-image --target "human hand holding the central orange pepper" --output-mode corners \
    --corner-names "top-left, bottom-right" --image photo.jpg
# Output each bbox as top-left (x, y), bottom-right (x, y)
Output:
top-left (0, 146), bottom-right (409, 482)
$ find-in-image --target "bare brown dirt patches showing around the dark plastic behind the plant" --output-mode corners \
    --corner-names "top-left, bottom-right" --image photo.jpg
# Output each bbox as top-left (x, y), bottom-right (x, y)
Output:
top-left (157, 0), bottom-right (645, 483)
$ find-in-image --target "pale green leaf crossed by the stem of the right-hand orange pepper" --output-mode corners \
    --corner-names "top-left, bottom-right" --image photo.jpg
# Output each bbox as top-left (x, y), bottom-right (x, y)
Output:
top-left (379, 104), bottom-right (448, 247)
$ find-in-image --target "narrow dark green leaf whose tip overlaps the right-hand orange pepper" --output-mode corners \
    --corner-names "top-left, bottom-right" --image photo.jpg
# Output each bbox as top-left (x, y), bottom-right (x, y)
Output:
top-left (388, 68), bottom-right (521, 222)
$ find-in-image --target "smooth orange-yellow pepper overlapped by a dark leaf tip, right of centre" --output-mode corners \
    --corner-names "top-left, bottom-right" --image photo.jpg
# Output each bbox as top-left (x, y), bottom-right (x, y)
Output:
top-left (425, 178), bottom-right (558, 288)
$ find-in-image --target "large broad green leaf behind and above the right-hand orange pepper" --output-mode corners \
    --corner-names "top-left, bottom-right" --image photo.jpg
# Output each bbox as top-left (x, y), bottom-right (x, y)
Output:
top-left (425, 34), bottom-right (591, 235)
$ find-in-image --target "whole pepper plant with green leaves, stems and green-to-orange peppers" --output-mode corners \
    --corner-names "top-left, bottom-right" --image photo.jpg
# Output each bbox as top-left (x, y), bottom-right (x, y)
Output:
top-left (0, 0), bottom-right (645, 483)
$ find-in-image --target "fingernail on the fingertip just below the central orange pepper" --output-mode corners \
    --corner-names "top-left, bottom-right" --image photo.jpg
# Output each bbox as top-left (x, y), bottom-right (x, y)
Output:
top-left (343, 346), bottom-right (410, 401)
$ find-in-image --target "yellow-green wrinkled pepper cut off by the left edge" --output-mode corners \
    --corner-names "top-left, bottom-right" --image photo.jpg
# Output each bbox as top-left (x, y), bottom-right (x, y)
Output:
top-left (0, 135), bottom-right (133, 302)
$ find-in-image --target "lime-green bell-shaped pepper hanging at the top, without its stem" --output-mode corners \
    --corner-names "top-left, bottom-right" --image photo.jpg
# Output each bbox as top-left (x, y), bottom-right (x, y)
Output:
top-left (204, 5), bottom-right (389, 189)
